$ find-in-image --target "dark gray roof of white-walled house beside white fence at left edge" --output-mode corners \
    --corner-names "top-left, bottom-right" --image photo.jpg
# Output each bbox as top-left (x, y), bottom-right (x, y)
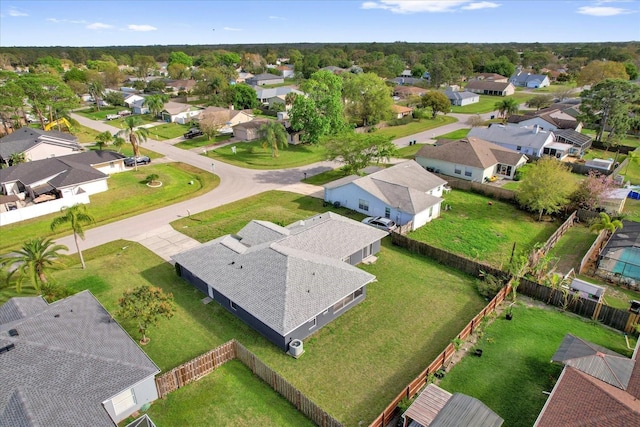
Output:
top-left (0, 150), bottom-right (120, 188)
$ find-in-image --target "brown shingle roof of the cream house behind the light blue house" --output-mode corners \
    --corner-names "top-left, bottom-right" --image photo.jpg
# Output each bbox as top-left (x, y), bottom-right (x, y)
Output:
top-left (416, 137), bottom-right (524, 169)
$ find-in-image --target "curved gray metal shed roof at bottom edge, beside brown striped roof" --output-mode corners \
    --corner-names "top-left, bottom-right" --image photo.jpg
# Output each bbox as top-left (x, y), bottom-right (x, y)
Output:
top-left (429, 393), bottom-right (504, 427)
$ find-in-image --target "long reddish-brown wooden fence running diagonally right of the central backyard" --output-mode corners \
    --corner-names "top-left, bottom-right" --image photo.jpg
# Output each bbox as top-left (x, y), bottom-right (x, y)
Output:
top-left (369, 284), bottom-right (511, 427)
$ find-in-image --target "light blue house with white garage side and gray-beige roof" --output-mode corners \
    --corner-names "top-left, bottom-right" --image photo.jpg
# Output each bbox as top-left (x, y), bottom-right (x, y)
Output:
top-left (324, 160), bottom-right (447, 230)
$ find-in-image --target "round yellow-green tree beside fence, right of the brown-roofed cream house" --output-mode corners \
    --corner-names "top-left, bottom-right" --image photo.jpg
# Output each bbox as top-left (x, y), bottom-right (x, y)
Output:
top-left (516, 157), bottom-right (576, 221)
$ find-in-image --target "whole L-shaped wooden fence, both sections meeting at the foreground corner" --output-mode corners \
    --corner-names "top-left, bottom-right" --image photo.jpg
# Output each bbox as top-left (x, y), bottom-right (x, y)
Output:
top-left (156, 340), bottom-right (342, 427)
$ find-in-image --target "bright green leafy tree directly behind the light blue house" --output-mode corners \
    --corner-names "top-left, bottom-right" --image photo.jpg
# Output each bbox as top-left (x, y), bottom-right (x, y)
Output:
top-left (324, 131), bottom-right (397, 174)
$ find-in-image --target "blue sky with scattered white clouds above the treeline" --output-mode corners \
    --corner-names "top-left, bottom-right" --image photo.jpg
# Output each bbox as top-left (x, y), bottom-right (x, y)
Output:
top-left (0, 0), bottom-right (640, 47)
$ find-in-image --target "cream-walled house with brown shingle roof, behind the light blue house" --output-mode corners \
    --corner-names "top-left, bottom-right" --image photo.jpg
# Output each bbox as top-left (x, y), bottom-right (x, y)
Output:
top-left (416, 137), bottom-right (527, 182)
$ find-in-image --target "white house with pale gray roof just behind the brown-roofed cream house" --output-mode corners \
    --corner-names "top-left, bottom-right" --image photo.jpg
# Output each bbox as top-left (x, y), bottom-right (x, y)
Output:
top-left (467, 124), bottom-right (573, 160)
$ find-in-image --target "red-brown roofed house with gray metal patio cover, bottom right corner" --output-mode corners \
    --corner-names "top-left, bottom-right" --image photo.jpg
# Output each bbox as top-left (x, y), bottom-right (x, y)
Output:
top-left (534, 334), bottom-right (640, 427)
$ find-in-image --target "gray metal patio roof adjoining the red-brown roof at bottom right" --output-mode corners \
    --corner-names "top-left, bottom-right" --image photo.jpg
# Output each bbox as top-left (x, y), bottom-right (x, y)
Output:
top-left (551, 334), bottom-right (635, 390)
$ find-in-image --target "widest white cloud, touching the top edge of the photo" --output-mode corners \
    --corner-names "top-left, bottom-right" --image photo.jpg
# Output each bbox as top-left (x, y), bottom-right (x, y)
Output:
top-left (361, 0), bottom-right (500, 13)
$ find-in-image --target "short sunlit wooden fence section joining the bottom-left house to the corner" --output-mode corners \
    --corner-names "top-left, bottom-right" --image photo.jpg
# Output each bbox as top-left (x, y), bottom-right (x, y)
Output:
top-left (156, 340), bottom-right (236, 397)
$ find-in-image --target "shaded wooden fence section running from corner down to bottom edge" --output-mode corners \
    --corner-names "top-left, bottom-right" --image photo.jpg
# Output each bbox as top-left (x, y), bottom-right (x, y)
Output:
top-left (234, 341), bottom-right (342, 427)
